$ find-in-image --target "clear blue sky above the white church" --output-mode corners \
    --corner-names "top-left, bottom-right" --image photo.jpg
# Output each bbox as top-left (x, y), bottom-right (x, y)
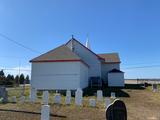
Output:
top-left (0, 0), bottom-right (160, 78)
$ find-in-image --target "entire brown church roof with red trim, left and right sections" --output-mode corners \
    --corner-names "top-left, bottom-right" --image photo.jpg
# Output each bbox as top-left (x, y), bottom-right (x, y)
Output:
top-left (30, 38), bottom-right (120, 67)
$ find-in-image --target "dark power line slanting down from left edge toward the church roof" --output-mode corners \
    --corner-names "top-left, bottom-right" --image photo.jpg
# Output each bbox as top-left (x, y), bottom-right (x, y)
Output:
top-left (0, 33), bottom-right (40, 54)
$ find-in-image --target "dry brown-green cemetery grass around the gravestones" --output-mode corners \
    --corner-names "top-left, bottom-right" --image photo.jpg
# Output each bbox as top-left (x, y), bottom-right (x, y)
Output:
top-left (0, 85), bottom-right (160, 120)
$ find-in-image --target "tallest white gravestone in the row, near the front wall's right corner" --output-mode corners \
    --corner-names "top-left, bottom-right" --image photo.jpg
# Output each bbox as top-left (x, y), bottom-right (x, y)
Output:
top-left (75, 89), bottom-right (83, 106)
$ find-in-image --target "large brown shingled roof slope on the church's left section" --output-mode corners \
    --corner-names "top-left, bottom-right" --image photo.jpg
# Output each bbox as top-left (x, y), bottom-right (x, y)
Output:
top-left (30, 45), bottom-right (81, 62)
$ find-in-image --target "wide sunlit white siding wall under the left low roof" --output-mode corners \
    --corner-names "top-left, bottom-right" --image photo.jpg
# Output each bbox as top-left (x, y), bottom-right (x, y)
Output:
top-left (31, 62), bottom-right (86, 90)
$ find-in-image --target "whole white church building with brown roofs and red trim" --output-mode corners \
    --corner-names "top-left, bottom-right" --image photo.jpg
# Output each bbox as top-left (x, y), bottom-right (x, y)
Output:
top-left (30, 38), bottom-right (124, 95)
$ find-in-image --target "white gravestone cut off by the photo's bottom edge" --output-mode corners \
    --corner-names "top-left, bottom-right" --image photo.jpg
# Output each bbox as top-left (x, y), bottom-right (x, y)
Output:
top-left (41, 105), bottom-right (50, 120)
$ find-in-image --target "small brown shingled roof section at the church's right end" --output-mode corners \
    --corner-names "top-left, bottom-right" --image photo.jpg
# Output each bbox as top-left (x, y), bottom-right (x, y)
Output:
top-left (98, 53), bottom-right (120, 63)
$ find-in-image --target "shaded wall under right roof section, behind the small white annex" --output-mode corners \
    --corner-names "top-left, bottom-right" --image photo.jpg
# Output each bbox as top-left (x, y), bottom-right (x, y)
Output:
top-left (101, 63), bottom-right (120, 83)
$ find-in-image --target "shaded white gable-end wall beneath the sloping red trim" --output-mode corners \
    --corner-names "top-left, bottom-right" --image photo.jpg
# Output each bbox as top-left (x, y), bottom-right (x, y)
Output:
top-left (67, 41), bottom-right (101, 77)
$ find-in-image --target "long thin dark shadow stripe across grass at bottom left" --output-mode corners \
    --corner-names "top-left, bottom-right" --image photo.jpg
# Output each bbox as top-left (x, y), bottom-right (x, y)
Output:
top-left (0, 109), bottom-right (67, 118)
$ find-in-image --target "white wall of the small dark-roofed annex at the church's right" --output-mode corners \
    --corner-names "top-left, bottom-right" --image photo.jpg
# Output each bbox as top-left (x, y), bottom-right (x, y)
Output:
top-left (108, 73), bottom-right (124, 87)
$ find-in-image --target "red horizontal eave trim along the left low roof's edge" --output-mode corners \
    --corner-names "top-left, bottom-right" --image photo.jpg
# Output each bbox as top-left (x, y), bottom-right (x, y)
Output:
top-left (30, 60), bottom-right (89, 67)
